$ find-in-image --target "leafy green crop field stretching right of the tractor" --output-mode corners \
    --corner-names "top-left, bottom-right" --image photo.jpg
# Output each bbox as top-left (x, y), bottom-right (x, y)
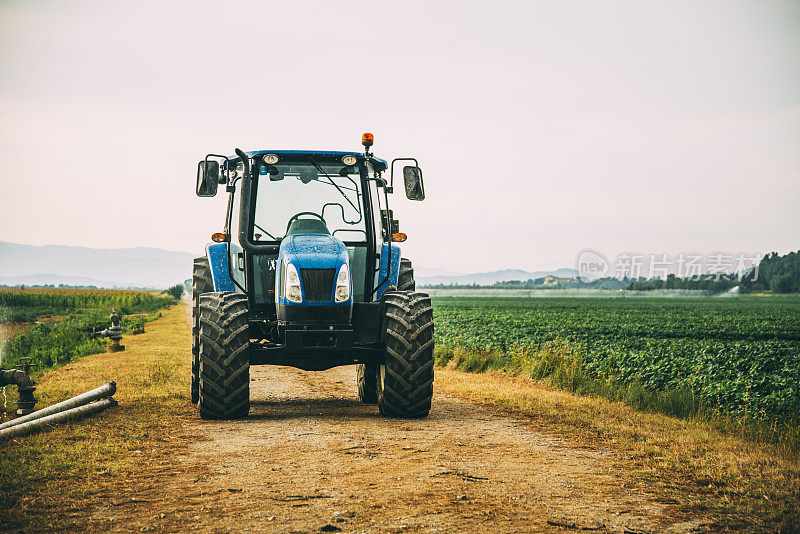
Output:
top-left (434, 296), bottom-right (800, 442)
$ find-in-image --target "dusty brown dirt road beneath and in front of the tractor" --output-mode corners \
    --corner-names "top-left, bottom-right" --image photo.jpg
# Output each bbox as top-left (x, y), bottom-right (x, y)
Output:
top-left (84, 308), bottom-right (698, 532)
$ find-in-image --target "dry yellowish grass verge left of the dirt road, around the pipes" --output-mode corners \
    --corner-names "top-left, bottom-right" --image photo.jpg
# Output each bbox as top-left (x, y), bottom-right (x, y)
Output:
top-left (0, 303), bottom-right (191, 530)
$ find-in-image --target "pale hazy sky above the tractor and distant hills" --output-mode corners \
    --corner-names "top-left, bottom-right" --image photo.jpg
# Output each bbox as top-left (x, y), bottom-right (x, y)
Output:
top-left (0, 0), bottom-right (800, 272)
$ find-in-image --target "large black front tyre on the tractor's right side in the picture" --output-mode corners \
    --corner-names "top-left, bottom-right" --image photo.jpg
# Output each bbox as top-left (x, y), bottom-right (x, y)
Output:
top-left (378, 291), bottom-right (433, 418)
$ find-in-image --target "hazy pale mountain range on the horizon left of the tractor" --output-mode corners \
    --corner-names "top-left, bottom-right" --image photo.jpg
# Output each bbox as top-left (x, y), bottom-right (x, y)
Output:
top-left (0, 241), bottom-right (193, 288)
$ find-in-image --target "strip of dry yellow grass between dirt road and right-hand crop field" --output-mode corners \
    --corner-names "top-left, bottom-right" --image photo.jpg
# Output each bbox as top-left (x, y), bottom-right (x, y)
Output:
top-left (436, 368), bottom-right (800, 532)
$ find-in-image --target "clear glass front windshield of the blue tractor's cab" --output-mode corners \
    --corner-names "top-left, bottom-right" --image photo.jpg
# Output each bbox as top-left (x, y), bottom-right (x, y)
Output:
top-left (253, 162), bottom-right (367, 242)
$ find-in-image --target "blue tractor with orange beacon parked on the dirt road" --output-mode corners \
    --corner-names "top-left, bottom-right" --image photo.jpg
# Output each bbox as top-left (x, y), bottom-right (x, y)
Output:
top-left (191, 134), bottom-right (434, 419)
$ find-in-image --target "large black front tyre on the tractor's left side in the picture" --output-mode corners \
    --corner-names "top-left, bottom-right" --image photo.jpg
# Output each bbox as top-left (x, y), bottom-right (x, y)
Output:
top-left (197, 292), bottom-right (250, 419)
